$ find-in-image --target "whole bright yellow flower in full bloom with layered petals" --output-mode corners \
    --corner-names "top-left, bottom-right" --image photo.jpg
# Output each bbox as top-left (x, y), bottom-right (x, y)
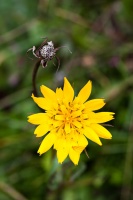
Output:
top-left (28, 78), bottom-right (114, 165)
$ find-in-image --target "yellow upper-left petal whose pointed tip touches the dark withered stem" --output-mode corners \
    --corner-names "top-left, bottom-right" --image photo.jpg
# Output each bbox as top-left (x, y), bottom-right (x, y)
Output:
top-left (31, 94), bottom-right (52, 110)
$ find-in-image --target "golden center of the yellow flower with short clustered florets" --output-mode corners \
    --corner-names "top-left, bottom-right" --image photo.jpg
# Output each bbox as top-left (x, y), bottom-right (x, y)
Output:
top-left (50, 102), bottom-right (84, 134)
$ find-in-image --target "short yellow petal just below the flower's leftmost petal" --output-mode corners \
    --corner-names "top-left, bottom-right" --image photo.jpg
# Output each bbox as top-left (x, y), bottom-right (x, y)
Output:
top-left (34, 124), bottom-right (50, 137)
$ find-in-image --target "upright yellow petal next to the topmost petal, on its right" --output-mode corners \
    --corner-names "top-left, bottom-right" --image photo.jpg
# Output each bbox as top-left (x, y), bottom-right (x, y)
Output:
top-left (78, 81), bottom-right (92, 103)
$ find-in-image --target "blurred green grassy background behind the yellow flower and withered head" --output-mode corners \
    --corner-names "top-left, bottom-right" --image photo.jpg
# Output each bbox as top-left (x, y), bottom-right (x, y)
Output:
top-left (0, 0), bottom-right (133, 200)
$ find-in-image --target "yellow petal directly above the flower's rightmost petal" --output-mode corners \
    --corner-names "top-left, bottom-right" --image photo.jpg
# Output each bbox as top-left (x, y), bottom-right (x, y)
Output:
top-left (84, 99), bottom-right (105, 111)
